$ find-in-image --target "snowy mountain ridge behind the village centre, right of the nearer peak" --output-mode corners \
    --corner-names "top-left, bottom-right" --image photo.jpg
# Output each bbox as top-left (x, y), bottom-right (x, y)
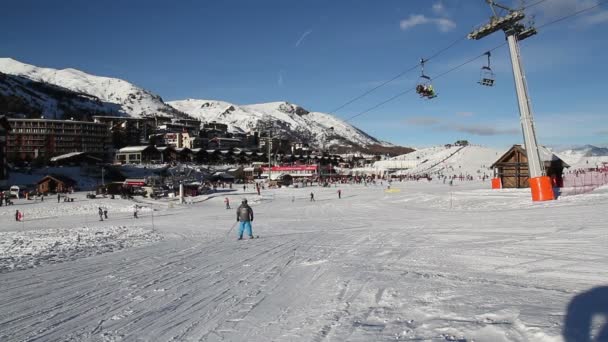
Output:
top-left (167, 99), bottom-right (384, 146)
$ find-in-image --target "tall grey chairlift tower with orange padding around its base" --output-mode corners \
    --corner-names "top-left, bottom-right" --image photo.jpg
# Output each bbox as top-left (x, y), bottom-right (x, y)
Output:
top-left (467, 0), bottom-right (555, 201)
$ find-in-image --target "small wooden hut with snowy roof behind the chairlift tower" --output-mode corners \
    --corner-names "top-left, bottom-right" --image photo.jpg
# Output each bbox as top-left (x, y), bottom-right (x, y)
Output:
top-left (492, 145), bottom-right (570, 188)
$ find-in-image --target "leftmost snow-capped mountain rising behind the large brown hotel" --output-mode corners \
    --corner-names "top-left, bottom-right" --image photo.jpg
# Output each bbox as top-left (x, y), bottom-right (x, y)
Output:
top-left (0, 58), bottom-right (181, 117)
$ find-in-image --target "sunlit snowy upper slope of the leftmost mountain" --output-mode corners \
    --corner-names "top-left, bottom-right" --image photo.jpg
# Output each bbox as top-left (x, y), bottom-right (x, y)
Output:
top-left (0, 58), bottom-right (179, 117)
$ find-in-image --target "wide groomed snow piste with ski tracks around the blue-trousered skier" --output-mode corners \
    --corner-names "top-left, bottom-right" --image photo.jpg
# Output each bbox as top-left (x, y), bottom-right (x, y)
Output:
top-left (0, 180), bottom-right (608, 342)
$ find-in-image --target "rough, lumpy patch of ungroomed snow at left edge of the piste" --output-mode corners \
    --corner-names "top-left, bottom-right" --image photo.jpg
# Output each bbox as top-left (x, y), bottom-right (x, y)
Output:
top-left (0, 226), bottom-right (162, 273)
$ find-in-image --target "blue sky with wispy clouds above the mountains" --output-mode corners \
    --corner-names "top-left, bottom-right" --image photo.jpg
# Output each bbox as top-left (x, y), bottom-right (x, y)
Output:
top-left (0, 0), bottom-right (608, 148)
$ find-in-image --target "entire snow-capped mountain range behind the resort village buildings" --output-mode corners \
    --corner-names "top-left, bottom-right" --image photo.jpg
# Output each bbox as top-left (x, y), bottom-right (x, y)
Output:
top-left (0, 58), bottom-right (395, 149)
